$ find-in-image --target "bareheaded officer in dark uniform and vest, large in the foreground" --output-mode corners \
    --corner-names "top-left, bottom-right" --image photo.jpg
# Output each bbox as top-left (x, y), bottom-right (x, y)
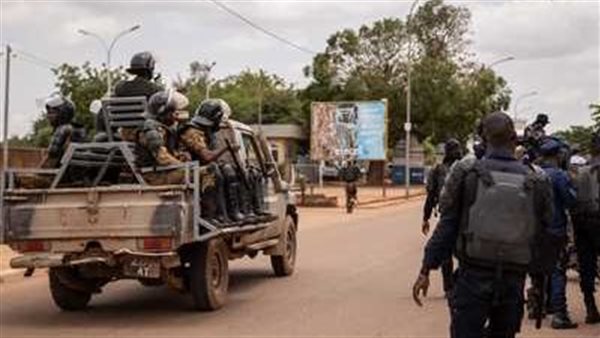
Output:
top-left (413, 113), bottom-right (553, 338)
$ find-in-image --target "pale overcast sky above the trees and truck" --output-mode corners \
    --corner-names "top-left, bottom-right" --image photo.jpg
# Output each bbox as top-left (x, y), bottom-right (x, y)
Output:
top-left (0, 0), bottom-right (600, 135)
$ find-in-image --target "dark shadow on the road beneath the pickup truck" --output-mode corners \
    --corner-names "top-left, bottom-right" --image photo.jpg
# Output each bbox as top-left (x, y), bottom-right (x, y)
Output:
top-left (2, 267), bottom-right (278, 331)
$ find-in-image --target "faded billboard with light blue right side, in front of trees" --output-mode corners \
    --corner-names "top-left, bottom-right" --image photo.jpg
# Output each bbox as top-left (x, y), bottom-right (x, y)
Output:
top-left (310, 100), bottom-right (387, 161)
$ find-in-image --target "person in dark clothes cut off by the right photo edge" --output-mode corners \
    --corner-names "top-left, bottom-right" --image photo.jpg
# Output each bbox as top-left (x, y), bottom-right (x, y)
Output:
top-left (571, 131), bottom-right (600, 324)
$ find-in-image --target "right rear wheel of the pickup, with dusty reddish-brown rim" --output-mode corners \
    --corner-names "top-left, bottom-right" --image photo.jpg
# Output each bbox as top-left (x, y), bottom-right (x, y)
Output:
top-left (189, 239), bottom-right (229, 311)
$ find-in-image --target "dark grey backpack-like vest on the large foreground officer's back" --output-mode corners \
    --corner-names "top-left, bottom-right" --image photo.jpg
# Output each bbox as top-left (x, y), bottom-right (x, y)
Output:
top-left (459, 161), bottom-right (537, 268)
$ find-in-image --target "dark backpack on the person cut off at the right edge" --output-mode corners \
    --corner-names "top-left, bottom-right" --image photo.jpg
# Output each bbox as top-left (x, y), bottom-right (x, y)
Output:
top-left (575, 165), bottom-right (600, 214)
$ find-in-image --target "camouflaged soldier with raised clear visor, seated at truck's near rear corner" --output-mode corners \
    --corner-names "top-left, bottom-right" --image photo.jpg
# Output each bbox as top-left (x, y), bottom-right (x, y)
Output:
top-left (136, 91), bottom-right (189, 185)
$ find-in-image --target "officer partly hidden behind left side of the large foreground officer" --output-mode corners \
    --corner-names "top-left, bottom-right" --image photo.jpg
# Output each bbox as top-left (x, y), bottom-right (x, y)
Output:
top-left (421, 138), bottom-right (462, 297)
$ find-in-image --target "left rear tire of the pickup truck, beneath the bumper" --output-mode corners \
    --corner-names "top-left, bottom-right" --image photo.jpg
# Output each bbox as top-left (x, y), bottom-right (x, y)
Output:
top-left (48, 268), bottom-right (92, 311)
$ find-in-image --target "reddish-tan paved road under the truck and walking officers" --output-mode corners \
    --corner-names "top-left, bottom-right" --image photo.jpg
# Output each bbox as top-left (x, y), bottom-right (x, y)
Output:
top-left (0, 201), bottom-right (600, 338)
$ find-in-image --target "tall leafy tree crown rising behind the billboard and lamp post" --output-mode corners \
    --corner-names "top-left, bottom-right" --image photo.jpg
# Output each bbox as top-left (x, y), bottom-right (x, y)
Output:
top-left (303, 0), bottom-right (510, 146)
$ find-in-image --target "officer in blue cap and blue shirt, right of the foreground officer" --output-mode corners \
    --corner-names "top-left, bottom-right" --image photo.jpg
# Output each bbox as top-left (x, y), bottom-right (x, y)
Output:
top-left (539, 137), bottom-right (577, 329)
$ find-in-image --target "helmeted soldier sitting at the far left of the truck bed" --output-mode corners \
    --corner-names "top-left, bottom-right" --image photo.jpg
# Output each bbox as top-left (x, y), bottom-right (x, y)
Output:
top-left (17, 94), bottom-right (85, 189)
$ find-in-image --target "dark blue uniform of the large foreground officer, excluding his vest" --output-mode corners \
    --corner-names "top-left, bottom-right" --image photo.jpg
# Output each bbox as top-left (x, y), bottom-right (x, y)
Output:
top-left (423, 150), bottom-right (553, 338)
